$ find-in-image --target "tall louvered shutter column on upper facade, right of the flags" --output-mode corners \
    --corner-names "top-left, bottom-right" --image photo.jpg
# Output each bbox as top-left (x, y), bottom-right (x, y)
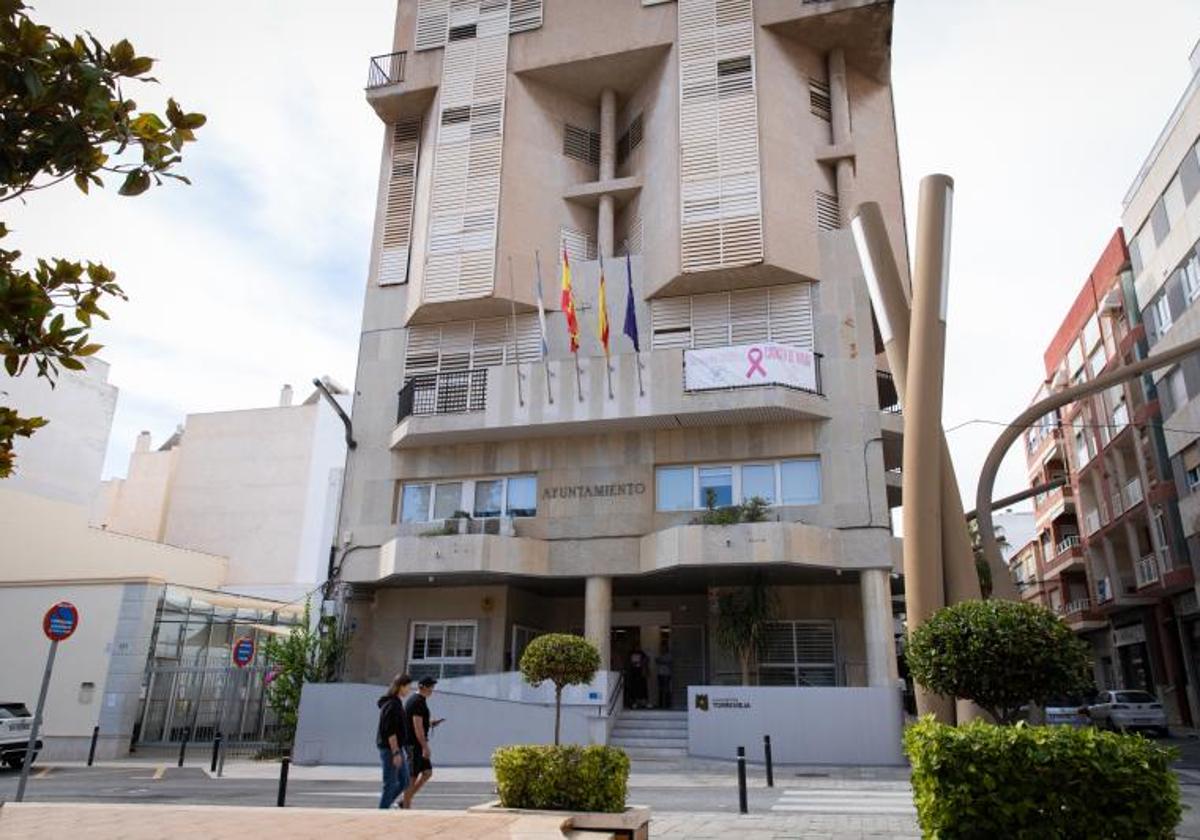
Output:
top-left (678, 0), bottom-right (762, 272)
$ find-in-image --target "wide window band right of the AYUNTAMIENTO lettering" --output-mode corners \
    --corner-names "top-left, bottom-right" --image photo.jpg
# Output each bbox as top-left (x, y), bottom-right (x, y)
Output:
top-left (655, 457), bottom-right (821, 512)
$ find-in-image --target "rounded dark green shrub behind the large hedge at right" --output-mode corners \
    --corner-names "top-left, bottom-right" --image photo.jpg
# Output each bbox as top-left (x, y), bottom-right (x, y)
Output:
top-left (906, 600), bottom-right (1092, 724)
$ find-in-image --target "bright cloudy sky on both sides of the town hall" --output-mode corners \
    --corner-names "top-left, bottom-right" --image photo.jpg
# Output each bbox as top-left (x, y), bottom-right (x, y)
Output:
top-left (14, 0), bottom-right (1200, 508)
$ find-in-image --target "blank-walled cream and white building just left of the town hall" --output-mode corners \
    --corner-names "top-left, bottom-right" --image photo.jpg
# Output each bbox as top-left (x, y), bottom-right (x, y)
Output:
top-left (92, 380), bottom-right (348, 601)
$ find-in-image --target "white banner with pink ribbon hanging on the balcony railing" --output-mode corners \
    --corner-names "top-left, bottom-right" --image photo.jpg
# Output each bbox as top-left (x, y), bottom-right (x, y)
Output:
top-left (684, 342), bottom-right (817, 391)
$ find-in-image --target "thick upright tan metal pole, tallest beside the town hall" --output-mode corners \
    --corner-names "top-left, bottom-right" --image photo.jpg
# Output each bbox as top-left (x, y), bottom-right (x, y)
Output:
top-left (902, 175), bottom-right (961, 724)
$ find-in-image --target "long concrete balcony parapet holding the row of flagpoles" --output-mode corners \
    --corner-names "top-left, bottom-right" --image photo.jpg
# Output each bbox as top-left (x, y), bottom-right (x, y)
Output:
top-left (391, 349), bottom-right (830, 449)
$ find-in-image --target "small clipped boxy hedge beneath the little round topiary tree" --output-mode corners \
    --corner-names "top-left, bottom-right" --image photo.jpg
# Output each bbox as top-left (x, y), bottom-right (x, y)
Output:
top-left (492, 745), bottom-right (629, 814)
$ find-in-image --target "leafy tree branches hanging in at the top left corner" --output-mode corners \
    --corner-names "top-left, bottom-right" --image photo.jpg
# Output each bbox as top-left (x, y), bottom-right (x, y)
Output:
top-left (0, 0), bottom-right (205, 478)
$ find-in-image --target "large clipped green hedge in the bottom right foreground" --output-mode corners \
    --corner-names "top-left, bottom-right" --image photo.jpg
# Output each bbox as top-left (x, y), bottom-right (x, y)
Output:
top-left (904, 718), bottom-right (1181, 840)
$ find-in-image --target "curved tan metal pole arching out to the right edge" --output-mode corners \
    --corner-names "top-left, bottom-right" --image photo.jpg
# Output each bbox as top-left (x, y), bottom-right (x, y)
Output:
top-left (976, 338), bottom-right (1200, 578)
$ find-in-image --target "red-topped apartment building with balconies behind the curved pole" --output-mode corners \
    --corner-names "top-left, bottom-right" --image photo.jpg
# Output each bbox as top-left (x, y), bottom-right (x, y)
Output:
top-left (1012, 230), bottom-right (1196, 722)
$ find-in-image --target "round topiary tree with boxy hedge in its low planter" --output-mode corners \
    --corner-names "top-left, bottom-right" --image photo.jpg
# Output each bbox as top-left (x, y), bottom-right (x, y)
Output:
top-left (472, 634), bottom-right (650, 840)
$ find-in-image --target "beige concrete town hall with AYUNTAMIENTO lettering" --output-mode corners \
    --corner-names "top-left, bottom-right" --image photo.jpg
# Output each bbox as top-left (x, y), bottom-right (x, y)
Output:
top-left (340, 0), bottom-right (907, 707)
